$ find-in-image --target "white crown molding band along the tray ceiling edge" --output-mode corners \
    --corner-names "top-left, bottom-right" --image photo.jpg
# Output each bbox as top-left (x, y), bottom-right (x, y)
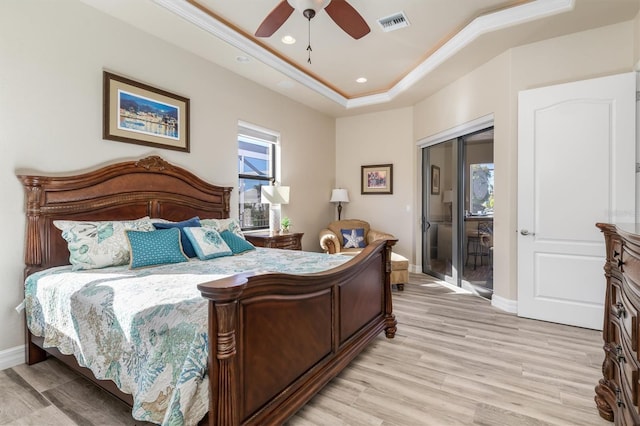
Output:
top-left (153, 0), bottom-right (575, 109)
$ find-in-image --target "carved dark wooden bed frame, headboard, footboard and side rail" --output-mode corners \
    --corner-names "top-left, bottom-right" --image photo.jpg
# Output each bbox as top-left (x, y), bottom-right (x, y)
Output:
top-left (18, 156), bottom-right (396, 425)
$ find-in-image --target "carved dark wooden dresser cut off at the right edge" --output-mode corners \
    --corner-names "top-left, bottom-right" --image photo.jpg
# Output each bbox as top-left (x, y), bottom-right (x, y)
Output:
top-left (595, 223), bottom-right (640, 425)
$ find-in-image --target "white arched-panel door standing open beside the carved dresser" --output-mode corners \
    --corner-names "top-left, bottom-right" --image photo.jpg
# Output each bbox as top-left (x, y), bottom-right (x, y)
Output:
top-left (517, 73), bottom-right (636, 330)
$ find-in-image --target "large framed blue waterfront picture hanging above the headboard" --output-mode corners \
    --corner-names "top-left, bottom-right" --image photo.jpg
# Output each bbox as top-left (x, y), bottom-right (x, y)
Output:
top-left (102, 71), bottom-right (189, 152)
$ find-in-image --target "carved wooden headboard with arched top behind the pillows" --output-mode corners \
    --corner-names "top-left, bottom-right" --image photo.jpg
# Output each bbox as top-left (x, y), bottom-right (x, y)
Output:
top-left (18, 156), bottom-right (232, 276)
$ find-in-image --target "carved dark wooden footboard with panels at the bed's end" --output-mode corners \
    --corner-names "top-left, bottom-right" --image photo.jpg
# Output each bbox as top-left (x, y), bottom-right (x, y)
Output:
top-left (198, 240), bottom-right (396, 425)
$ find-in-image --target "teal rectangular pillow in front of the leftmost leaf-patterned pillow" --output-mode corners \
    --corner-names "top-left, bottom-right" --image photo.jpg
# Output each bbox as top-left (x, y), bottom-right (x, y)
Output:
top-left (127, 228), bottom-right (189, 269)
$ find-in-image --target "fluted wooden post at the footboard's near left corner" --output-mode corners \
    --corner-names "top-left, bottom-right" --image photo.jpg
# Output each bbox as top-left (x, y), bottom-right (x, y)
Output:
top-left (198, 274), bottom-right (252, 426)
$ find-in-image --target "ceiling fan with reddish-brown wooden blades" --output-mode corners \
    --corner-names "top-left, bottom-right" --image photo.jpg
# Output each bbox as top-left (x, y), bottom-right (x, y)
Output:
top-left (256, 0), bottom-right (371, 40)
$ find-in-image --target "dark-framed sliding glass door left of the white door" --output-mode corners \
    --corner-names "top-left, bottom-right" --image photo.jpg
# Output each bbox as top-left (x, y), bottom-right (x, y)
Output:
top-left (422, 128), bottom-right (494, 298)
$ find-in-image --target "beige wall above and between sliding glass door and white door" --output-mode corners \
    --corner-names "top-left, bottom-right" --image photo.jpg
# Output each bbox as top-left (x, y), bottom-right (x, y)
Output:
top-left (413, 21), bottom-right (637, 300)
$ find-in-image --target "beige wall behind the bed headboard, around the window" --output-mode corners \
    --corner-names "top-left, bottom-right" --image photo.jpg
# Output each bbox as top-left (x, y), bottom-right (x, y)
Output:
top-left (0, 0), bottom-right (338, 354)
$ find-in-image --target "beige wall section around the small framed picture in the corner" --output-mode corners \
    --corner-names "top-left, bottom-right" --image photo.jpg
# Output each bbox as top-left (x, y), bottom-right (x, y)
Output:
top-left (336, 108), bottom-right (416, 257)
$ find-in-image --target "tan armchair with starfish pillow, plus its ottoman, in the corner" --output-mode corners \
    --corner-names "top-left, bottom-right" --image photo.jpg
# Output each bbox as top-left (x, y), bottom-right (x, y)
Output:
top-left (320, 219), bottom-right (409, 290)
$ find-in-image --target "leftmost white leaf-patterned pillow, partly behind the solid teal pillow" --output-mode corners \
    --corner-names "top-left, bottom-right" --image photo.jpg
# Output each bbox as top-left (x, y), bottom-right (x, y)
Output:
top-left (53, 217), bottom-right (155, 271)
